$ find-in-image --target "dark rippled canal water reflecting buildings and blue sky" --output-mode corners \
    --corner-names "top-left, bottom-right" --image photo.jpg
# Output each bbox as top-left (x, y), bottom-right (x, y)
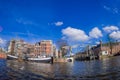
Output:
top-left (0, 56), bottom-right (120, 80)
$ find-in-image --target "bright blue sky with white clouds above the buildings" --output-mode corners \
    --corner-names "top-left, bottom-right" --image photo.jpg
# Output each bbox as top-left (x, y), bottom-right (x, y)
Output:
top-left (0, 0), bottom-right (120, 48)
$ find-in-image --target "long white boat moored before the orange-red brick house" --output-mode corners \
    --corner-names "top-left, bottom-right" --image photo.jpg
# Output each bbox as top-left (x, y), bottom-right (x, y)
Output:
top-left (28, 57), bottom-right (52, 63)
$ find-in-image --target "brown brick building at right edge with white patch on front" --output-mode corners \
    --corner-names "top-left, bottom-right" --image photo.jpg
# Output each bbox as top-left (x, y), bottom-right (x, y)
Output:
top-left (92, 42), bottom-right (120, 55)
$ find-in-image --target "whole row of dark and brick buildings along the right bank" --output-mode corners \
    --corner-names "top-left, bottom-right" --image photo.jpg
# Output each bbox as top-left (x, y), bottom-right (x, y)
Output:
top-left (75, 41), bottom-right (120, 60)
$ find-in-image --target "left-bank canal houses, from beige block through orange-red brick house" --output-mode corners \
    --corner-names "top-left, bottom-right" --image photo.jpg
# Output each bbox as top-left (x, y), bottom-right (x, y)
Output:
top-left (8, 40), bottom-right (55, 57)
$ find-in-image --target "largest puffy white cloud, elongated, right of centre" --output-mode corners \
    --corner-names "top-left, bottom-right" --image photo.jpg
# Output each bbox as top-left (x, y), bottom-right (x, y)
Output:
top-left (62, 27), bottom-right (89, 41)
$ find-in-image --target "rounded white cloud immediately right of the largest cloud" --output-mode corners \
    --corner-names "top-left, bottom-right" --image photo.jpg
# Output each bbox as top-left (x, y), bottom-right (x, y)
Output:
top-left (89, 27), bottom-right (103, 38)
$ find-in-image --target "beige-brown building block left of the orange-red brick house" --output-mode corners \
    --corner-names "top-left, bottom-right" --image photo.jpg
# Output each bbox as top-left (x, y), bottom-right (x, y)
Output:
top-left (8, 40), bottom-right (34, 55)
